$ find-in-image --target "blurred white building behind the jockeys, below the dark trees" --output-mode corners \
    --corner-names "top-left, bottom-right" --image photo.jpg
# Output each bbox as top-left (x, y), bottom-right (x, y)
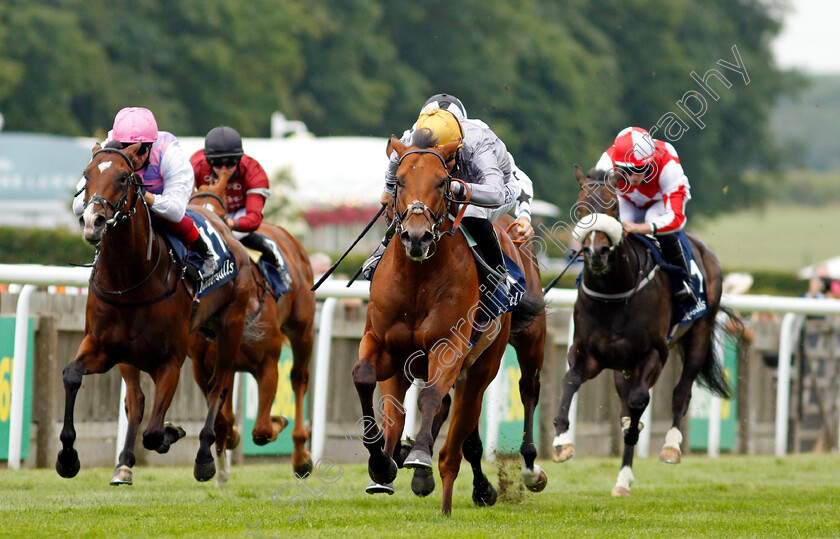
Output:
top-left (0, 130), bottom-right (559, 254)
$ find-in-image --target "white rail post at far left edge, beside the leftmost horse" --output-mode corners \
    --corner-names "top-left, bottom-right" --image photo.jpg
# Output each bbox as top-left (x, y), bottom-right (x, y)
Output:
top-left (9, 284), bottom-right (35, 470)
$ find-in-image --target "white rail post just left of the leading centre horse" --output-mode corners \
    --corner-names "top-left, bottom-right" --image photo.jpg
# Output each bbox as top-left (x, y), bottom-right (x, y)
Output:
top-left (312, 297), bottom-right (338, 462)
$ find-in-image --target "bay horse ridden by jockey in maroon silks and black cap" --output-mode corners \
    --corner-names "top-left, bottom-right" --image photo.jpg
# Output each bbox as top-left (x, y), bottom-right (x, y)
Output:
top-left (190, 172), bottom-right (315, 484)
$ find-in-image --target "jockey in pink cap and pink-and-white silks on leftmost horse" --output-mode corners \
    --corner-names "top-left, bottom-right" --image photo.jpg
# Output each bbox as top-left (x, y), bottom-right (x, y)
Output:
top-left (73, 107), bottom-right (218, 277)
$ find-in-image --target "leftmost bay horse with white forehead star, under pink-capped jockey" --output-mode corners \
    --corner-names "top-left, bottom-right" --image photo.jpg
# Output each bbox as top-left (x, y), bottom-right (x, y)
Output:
top-left (56, 143), bottom-right (252, 481)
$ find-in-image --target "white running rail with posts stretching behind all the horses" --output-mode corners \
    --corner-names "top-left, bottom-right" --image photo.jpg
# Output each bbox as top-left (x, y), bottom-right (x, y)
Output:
top-left (0, 264), bottom-right (840, 469)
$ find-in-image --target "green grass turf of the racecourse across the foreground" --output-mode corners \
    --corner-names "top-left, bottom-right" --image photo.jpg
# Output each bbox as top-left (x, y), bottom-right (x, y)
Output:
top-left (0, 455), bottom-right (840, 538)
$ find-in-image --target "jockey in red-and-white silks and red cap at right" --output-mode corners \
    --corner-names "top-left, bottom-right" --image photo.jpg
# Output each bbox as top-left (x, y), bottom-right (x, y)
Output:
top-left (595, 127), bottom-right (696, 304)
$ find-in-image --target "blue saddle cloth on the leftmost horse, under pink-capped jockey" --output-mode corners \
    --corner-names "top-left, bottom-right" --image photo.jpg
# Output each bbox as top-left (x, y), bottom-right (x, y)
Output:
top-left (158, 209), bottom-right (239, 298)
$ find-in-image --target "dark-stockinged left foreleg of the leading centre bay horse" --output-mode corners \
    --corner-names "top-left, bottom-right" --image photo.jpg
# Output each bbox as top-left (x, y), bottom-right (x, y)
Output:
top-left (352, 333), bottom-right (397, 485)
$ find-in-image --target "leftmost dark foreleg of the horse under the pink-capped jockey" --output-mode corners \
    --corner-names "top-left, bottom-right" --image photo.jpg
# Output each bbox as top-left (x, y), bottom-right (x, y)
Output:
top-left (55, 335), bottom-right (112, 479)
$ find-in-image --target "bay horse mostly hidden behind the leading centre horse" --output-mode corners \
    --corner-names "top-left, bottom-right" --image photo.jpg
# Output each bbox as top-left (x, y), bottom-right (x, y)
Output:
top-left (374, 215), bottom-right (548, 505)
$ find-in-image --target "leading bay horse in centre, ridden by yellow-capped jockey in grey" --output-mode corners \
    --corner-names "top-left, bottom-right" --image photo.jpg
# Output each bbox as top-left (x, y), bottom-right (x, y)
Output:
top-left (352, 134), bottom-right (544, 515)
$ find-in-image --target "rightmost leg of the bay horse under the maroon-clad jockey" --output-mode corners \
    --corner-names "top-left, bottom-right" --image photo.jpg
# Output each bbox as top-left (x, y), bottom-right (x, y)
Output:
top-left (289, 318), bottom-right (315, 477)
